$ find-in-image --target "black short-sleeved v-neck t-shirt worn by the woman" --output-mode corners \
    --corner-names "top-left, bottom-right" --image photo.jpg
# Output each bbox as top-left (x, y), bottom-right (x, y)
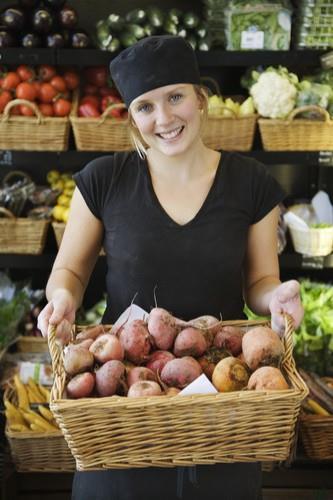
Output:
top-left (74, 152), bottom-right (284, 323)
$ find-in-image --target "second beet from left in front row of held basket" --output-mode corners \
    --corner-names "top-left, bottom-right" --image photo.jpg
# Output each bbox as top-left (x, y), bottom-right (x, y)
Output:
top-left (96, 359), bottom-right (127, 396)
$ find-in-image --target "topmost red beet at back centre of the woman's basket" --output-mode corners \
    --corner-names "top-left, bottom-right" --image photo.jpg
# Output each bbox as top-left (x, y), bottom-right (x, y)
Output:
top-left (148, 307), bottom-right (179, 351)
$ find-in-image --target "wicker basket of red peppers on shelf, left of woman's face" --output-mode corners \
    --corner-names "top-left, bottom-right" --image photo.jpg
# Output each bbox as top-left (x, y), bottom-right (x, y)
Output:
top-left (70, 94), bottom-right (134, 151)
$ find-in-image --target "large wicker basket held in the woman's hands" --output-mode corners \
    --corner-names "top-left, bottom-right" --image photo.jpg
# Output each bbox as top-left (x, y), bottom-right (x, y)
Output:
top-left (48, 318), bottom-right (308, 470)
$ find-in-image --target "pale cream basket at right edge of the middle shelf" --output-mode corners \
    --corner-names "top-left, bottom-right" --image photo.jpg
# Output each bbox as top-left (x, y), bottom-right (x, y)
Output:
top-left (289, 226), bottom-right (333, 257)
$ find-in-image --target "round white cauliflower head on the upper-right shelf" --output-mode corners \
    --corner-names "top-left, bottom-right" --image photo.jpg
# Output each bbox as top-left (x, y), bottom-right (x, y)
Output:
top-left (250, 71), bottom-right (297, 118)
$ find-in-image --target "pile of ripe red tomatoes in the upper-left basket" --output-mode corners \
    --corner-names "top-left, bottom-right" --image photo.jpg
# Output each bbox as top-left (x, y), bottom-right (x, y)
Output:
top-left (0, 64), bottom-right (79, 117)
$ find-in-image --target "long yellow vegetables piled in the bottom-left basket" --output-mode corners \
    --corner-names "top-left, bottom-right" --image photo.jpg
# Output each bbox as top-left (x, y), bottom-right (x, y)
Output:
top-left (4, 374), bottom-right (59, 433)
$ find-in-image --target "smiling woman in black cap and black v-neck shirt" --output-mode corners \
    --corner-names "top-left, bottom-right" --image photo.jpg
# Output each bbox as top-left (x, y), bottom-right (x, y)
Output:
top-left (39, 36), bottom-right (302, 500)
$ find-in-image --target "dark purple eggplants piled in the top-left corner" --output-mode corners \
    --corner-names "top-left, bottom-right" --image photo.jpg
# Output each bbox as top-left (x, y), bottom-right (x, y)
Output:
top-left (0, 0), bottom-right (91, 49)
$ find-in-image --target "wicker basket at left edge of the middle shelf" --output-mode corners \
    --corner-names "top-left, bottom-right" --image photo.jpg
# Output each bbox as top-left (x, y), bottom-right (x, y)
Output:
top-left (0, 207), bottom-right (49, 254)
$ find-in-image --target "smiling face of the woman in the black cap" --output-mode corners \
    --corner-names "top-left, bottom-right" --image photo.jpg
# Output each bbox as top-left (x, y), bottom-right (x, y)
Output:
top-left (130, 84), bottom-right (200, 156)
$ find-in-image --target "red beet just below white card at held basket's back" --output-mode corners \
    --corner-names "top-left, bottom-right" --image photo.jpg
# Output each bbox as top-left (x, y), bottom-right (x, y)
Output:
top-left (119, 319), bottom-right (151, 365)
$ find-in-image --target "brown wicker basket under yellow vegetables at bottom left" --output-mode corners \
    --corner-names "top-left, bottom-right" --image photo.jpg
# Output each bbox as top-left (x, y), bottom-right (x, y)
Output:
top-left (5, 387), bottom-right (75, 472)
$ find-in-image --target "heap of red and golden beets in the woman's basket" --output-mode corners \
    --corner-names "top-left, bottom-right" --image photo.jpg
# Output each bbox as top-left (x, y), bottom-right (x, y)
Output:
top-left (64, 307), bottom-right (289, 398)
